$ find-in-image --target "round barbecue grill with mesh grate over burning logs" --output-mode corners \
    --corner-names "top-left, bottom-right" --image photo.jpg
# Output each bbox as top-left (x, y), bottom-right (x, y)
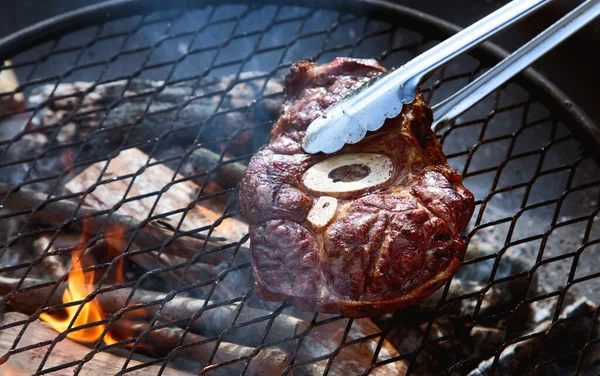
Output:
top-left (0, 0), bottom-right (600, 375)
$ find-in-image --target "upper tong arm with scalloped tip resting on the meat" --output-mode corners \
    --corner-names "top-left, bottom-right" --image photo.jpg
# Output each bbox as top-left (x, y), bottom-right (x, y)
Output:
top-left (302, 0), bottom-right (552, 153)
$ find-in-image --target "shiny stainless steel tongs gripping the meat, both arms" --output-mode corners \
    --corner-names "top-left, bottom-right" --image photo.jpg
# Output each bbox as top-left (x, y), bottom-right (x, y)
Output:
top-left (302, 0), bottom-right (600, 153)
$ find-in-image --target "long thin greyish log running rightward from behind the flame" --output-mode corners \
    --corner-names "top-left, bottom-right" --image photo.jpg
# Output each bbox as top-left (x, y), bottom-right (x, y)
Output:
top-left (0, 277), bottom-right (307, 346)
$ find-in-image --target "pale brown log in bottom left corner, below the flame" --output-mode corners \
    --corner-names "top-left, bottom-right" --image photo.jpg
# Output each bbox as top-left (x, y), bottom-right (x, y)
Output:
top-left (0, 312), bottom-right (191, 376)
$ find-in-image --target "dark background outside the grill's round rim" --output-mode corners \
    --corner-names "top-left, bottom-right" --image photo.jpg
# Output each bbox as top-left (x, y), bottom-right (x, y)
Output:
top-left (0, 0), bottom-right (600, 124)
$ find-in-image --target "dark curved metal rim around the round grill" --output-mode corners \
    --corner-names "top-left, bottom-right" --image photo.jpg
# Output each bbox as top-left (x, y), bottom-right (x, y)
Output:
top-left (0, 0), bottom-right (600, 372)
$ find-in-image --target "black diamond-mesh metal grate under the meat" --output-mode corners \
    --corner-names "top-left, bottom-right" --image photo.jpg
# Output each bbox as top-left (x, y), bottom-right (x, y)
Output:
top-left (0, 5), bottom-right (600, 375)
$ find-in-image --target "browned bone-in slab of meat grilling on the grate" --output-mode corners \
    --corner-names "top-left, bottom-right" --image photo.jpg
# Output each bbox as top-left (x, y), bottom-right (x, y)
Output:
top-left (240, 58), bottom-right (474, 317)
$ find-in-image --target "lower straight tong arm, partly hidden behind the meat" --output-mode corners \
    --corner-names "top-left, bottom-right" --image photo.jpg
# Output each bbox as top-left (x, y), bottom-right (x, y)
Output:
top-left (432, 0), bottom-right (600, 130)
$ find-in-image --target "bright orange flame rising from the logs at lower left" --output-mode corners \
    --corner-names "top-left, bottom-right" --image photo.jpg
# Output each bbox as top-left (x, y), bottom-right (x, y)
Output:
top-left (40, 220), bottom-right (125, 345)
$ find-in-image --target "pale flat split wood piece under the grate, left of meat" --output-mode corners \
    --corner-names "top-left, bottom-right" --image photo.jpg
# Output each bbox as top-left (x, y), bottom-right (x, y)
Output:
top-left (58, 149), bottom-right (252, 290)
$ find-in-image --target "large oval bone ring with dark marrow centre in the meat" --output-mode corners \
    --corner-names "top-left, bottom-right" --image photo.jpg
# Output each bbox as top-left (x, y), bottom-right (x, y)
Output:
top-left (303, 153), bottom-right (394, 196)
